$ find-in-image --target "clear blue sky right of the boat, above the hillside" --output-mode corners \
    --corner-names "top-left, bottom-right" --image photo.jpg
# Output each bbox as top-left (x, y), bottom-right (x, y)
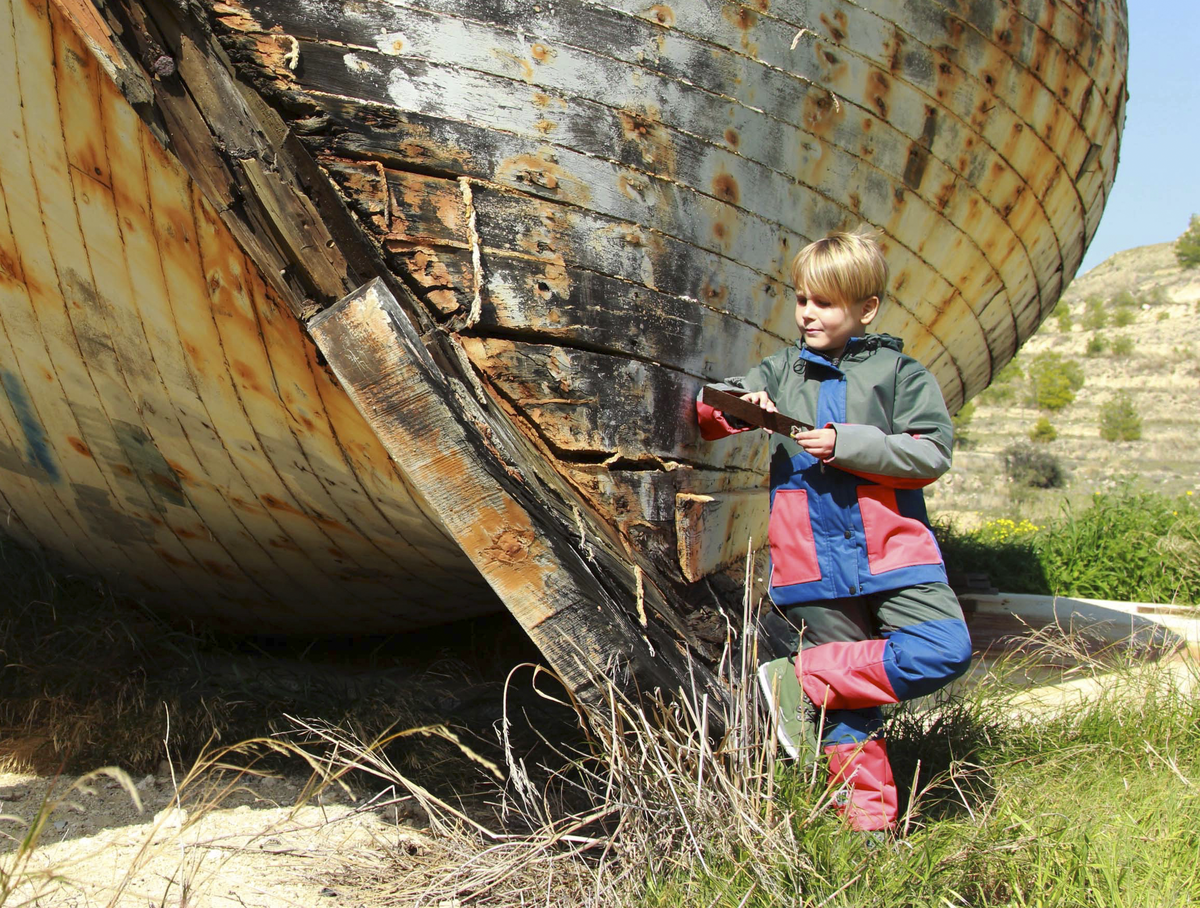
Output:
top-left (1079, 0), bottom-right (1200, 273)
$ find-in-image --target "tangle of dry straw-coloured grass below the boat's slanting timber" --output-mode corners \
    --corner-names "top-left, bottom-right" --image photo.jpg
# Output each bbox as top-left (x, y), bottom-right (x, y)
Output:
top-left (286, 558), bottom-right (829, 908)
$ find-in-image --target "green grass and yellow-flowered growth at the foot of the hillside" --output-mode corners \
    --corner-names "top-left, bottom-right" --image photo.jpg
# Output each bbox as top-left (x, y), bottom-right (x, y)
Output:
top-left (937, 491), bottom-right (1200, 605)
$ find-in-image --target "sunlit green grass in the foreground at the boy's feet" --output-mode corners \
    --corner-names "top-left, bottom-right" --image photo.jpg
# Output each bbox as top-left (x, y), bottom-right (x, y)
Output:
top-left (644, 647), bottom-right (1200, 908)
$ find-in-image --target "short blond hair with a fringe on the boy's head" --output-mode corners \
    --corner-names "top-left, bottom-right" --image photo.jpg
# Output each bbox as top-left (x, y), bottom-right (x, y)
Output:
top-left (792, 224), bottom-right (888, 306)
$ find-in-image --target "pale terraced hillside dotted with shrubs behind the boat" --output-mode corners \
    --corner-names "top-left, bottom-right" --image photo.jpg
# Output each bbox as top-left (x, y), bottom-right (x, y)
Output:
top-left (926, 237), bottom-right (1200, 527)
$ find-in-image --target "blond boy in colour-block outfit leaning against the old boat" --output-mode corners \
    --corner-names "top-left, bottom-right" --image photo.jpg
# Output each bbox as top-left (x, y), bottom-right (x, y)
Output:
top-left (697, 230), bottom-right (971, 830)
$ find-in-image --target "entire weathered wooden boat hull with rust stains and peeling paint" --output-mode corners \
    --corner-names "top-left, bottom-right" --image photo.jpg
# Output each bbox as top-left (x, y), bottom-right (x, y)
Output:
top-left (0, 0), bottom-right (1127, 695)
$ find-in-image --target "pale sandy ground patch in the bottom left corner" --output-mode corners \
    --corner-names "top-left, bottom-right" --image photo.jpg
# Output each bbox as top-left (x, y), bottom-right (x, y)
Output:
top-left (0, 772), bottom-right (428, 908)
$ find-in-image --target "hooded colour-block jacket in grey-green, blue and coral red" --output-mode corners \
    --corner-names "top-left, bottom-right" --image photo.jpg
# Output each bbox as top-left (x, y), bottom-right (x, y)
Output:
top-left (697, 335), bottom-right (954, 607)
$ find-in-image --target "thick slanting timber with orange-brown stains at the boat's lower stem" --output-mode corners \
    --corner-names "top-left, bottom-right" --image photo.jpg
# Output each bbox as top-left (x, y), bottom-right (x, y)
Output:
top-left (310, 281), bottom-right (716, 712)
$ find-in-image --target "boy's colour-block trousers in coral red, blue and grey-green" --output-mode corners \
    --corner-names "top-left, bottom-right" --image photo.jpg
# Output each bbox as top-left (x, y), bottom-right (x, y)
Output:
top-left (784, 583), bottom-right (971, 830)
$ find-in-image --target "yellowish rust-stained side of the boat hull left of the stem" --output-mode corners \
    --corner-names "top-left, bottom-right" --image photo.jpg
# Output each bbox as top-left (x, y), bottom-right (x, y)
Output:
top-left (0, 2), bottom-right (498, 632)
